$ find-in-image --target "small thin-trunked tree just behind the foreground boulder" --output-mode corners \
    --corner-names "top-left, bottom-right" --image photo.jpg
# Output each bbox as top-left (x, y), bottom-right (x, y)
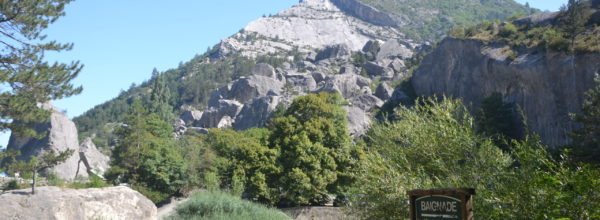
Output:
top-left (11, 149), bottom-right (75, 194)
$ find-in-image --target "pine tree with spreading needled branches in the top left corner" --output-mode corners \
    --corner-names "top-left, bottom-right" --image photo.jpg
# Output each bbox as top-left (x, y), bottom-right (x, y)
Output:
top-left (0, 0), bottom-right (82, 136)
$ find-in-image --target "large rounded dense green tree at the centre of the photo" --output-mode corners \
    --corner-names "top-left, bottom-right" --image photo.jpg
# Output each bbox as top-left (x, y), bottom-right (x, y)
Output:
top-left (270, 93), bottom-right (353, 205)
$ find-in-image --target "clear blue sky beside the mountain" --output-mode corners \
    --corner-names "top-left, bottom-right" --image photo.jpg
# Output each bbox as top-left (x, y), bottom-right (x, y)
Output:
top-left (0, 0), bottom-right (567, 146)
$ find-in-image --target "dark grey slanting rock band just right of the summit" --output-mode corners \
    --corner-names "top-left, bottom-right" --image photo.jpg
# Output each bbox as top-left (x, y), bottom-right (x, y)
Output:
top-left (331, 0), bottom-right (397, 26)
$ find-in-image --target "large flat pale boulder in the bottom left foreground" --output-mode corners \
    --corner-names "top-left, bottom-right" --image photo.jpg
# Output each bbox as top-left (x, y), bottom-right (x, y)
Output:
top-left (0, 186), bottom-right (157, 220)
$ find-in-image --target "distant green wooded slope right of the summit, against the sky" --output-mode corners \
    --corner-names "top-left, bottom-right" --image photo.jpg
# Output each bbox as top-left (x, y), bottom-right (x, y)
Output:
top-left (359, 0), bottom-right (537, 41)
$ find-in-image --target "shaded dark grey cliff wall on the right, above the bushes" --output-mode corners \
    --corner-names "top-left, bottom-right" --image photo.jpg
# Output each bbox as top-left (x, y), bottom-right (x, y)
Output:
top-left (412, 38), bottom-right (600, 146)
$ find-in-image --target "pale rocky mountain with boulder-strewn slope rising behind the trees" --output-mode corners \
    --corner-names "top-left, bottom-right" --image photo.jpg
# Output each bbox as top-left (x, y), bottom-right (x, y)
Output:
top-left (75, 0), bottom-right (532, 148)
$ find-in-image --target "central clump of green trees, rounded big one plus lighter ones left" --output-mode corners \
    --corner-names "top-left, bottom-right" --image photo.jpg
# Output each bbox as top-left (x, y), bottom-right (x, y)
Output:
top-left (178, 93), bottom-right (361, 206)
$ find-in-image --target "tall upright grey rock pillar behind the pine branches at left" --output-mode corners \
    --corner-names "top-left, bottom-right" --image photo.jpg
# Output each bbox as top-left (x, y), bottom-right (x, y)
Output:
top-left (7, 104), bottom-right (81, 180)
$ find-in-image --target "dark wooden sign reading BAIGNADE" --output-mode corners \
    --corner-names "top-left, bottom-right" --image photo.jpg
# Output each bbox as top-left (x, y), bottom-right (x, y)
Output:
top-left (407, 188), bottom-right (475, 220)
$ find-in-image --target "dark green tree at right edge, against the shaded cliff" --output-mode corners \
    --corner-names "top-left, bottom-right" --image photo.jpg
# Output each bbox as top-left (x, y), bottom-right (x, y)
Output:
top-left (571, 74), bottom-right (600, 163)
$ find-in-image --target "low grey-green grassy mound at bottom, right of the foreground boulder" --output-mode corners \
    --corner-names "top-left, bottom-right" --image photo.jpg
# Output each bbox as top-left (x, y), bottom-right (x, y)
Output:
top-left (169, 191), bottom-right (291, 220)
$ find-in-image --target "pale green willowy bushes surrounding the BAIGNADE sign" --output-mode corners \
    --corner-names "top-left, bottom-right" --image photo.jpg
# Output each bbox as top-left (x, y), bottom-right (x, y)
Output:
top-left (354, 99), bottom-right (600, 219)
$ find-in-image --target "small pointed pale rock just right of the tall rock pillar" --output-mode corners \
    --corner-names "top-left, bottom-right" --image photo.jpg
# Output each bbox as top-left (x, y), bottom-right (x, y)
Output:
top-left (79, 137), bottom-right (110, 176)
